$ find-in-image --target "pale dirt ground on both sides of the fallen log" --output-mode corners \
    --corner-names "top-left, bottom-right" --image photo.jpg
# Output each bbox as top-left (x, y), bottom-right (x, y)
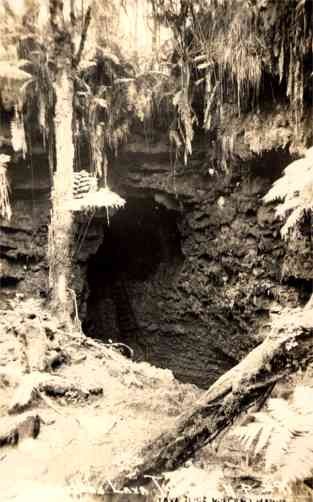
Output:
top-left (0, 300), bottom-right (310, 502)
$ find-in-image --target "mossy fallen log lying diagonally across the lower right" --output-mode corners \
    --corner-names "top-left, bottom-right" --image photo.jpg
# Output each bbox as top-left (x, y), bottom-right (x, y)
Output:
top-left (111, 309), bottom-right (313, 488)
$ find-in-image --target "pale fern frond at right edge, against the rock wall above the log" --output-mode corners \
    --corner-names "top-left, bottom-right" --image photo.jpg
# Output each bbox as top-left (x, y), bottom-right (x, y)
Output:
top-left (264, 147), bottom-right (313, 239)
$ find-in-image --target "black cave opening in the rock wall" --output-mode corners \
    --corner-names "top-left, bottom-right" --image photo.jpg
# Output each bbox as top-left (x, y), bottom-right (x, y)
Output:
top-left (83, 197), bottom-right (183, 360)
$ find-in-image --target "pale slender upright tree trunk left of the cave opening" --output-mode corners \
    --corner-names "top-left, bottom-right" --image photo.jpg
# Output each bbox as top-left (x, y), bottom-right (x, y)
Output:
top-left (48, 0), bottom-right (74, 320)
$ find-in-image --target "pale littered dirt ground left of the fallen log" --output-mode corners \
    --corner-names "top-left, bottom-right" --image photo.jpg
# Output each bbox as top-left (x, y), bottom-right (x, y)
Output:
top-left (0, 305), bottom-right (205, 501)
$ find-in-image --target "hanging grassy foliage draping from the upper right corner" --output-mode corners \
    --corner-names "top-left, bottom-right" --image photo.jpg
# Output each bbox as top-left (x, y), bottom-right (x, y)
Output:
top-left (150, 0), bottom-right (313, 165)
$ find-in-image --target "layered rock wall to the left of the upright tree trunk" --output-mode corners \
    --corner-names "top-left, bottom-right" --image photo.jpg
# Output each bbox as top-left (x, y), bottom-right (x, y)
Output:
top-left (0, 156), bottom-right (50, 308)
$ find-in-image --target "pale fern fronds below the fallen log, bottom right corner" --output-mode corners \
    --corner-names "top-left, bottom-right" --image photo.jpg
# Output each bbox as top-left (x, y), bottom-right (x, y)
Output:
top-left (236, 385), bottom-right (313, 486)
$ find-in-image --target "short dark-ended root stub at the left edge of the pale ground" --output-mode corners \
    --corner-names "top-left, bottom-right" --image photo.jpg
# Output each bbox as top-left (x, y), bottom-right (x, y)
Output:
top-left (0, 415), bottom-right (41, 447)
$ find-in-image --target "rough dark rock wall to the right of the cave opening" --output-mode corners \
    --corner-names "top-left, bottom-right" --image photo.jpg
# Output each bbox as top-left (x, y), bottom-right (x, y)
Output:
top-left (95, 139), bottom-right (312, 387)
